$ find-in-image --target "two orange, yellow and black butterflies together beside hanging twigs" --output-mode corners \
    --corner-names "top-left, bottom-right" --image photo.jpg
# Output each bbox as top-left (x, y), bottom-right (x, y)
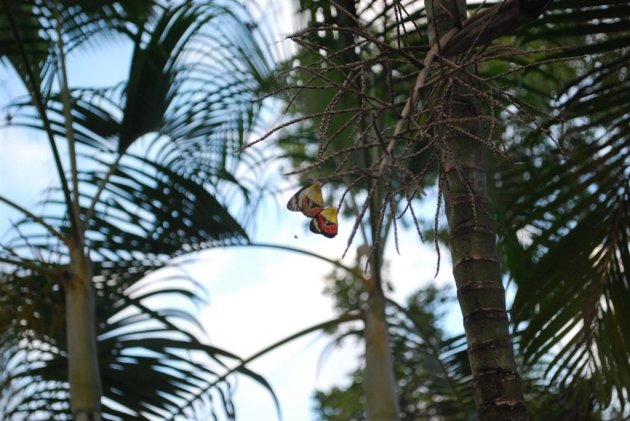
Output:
top-left (287, 183), bottom-right (338, 238)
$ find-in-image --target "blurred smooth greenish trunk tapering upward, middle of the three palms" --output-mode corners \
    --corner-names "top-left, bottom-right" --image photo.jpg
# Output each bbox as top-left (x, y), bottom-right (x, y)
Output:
top-left (364, 245), bottom-right (399, 421)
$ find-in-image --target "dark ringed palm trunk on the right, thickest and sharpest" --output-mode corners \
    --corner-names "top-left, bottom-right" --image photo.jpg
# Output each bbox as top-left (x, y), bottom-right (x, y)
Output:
top-left (427, 0), bottom-right (527, 421)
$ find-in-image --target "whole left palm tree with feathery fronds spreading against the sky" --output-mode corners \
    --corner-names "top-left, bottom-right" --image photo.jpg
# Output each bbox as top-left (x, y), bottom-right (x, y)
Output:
top-left (0, 0), bottom-right (280, 419)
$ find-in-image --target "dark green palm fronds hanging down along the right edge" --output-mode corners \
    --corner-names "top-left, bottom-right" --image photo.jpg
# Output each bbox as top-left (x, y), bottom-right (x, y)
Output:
top-left (501, 1), bottom-right (630, 410)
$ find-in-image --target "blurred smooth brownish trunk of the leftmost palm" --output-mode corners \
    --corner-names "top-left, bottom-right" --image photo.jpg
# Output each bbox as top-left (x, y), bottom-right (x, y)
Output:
top-left (64, 248), bottom-right (102, 421)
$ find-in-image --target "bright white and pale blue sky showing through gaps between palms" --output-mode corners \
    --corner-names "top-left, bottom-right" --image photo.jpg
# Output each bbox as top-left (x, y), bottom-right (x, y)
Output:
top-left (0, 4), bottom-right (461, 421)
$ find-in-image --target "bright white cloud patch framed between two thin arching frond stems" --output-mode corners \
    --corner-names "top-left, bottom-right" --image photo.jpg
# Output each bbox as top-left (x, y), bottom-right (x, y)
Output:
top-left (200, 250), bottom-right (333, 355)
